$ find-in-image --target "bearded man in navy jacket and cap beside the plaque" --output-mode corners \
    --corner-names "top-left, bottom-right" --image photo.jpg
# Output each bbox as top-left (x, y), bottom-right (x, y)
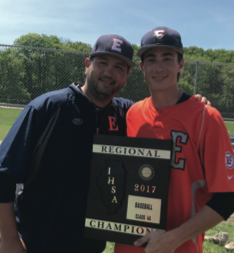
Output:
top-left (0, 35), bottom-right (135, 253)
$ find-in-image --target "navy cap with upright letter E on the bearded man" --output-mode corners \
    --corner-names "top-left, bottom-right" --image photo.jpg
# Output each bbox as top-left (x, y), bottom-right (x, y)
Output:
top-left (89, 34), bottom-right (135, 68)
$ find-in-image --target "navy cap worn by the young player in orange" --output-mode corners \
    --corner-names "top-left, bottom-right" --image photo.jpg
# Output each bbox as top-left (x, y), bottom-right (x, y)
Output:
top-left (137, 26), bottom-right (184, 57)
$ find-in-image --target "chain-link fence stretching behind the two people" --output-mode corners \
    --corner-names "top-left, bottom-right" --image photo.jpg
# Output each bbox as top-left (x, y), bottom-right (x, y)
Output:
top-left (0, 44), bottom-right (234, 141)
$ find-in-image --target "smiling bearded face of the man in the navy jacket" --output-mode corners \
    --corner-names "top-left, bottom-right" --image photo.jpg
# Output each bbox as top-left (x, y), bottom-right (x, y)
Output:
top-left (85, 54), bottom-right (130, 99)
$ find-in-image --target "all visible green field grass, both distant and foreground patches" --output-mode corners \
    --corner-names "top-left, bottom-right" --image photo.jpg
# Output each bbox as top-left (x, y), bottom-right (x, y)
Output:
top-left (0, 108), bottom-right (234, 253)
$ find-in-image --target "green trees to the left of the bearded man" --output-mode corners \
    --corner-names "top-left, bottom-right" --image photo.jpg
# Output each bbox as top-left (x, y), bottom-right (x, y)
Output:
top-left (0, 33), bottom-right (91, 104)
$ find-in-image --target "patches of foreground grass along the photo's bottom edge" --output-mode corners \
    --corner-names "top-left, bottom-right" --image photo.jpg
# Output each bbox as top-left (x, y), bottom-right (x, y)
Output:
top-left (103, 223), bottom-right (234, 253)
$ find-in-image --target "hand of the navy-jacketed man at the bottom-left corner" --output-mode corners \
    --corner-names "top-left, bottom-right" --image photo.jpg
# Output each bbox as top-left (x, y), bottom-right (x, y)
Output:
top-left (0, 238), bottom-right (27, 253)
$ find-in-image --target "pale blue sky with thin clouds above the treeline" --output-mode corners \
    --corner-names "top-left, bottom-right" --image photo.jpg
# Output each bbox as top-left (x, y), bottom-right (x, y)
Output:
top-left (0, 0), bottom-right (234, 50)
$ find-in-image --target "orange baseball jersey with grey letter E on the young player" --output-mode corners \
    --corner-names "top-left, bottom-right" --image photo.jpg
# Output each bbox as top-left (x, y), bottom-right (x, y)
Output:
top-left (115, 96), bottom-right (234, 253)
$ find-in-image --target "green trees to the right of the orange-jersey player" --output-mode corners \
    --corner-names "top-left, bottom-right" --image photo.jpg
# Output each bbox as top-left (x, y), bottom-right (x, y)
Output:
top-left (179, 46), bottom-right (234, 115)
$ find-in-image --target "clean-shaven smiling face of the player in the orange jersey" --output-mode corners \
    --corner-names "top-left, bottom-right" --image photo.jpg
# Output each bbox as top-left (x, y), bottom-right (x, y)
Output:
top-left (140, 47), bottom-right (184, 91)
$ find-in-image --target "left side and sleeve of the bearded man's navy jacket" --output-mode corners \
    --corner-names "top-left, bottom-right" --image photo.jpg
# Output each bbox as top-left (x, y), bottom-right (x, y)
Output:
top-left (0, 85), bottom-right (96, 253)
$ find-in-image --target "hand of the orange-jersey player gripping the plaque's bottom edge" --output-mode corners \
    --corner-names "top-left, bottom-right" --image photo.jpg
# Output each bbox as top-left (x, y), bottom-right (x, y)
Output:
top-left (134, 231), bottom-right (179, 253)
